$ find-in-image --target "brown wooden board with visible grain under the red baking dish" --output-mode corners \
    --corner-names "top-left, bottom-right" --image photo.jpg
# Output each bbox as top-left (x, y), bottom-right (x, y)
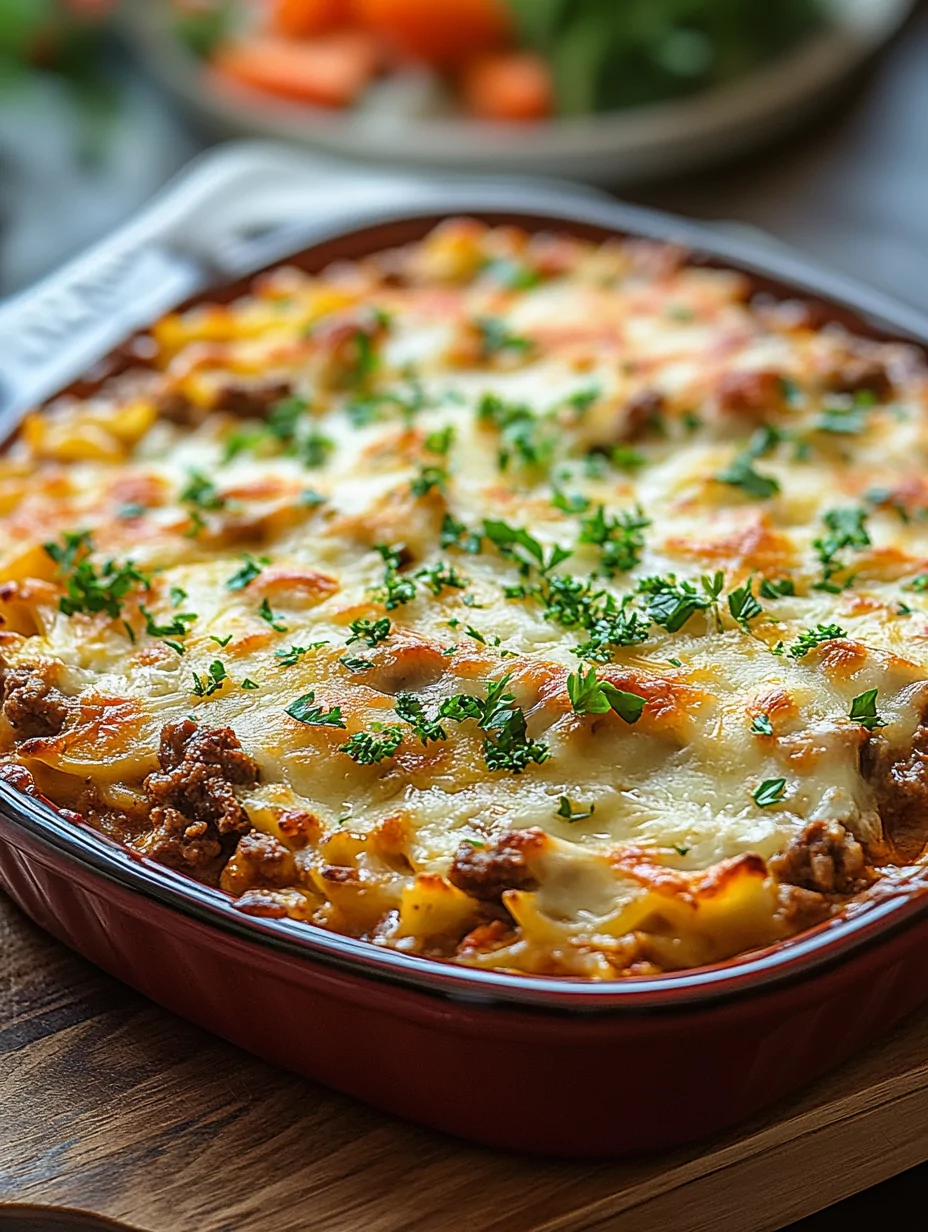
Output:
top-left (0, 896), bottom-right (928, 1232)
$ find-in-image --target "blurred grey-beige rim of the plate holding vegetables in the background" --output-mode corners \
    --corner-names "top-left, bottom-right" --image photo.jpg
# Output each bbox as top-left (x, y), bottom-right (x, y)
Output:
top-left (124, 0), bottom-right (914, 187)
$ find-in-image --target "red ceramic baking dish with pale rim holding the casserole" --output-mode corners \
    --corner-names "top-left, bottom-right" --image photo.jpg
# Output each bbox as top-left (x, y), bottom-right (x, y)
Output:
top-left (0, 141), bottom-right (928, 1156)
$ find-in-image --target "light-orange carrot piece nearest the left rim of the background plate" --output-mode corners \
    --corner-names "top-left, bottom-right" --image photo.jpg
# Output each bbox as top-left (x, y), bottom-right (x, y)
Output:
top-left (211, 31), bottom-right (378, 107)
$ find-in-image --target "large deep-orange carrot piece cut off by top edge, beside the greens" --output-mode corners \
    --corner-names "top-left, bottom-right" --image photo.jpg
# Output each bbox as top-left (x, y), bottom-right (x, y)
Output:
top-left (356, 0), bottom-right (513, 67)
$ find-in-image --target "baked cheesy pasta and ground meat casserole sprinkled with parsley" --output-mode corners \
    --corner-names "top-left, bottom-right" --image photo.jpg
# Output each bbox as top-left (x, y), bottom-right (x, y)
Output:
top-left (0, 222), bottom-right (928, 978)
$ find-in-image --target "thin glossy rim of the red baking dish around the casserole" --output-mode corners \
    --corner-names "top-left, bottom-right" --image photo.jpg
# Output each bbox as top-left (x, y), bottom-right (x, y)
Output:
top-left (0, 186), bottom-right (928, 1018)
